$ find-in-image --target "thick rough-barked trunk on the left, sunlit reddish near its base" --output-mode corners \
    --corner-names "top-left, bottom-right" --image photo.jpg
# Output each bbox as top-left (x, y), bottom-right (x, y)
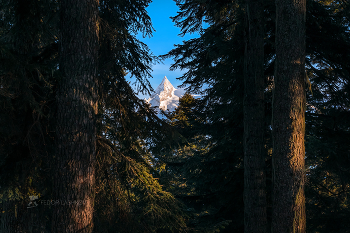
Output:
top-left (52, 0), bottom-right (98, 233)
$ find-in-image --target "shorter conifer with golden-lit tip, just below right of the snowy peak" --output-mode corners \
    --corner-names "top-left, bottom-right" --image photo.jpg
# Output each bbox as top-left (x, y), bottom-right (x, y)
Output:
top-left (161, 93), bottom-right (235, 233)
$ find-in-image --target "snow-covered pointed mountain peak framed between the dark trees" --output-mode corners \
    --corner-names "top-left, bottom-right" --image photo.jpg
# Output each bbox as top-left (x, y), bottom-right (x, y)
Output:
top-left (146, 76), bottom-right (185, 111)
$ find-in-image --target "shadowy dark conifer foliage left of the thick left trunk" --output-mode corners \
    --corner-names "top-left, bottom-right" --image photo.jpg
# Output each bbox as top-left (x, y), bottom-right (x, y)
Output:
top-left (0, 1), bottom-right (57, 232)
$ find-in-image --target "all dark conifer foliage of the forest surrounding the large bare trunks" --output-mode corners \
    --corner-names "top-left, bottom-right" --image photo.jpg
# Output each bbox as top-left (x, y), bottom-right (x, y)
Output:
top-left (0, 0), bottom-right (350, 233)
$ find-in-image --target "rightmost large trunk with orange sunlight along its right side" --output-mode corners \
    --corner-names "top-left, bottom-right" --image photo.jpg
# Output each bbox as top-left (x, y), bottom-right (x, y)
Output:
top-left (272, 0), bottom-right (306, 233)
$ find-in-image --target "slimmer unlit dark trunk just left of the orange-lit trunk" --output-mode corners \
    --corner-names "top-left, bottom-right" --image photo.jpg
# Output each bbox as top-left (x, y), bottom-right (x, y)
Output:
top-left (244, 0), bottom-right (267, 233)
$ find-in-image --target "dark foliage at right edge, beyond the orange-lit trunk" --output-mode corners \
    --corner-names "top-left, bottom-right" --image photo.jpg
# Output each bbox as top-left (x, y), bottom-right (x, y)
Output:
top-left (306, 1), bottom-right (350, 232)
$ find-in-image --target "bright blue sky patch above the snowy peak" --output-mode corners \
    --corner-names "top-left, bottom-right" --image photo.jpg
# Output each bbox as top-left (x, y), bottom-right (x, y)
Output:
top-left (131, 0), bottom-right (199, 97)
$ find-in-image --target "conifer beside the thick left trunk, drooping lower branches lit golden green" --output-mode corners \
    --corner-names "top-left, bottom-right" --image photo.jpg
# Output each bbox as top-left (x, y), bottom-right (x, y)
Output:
top-left (94, 1), bottom-right (185, 232)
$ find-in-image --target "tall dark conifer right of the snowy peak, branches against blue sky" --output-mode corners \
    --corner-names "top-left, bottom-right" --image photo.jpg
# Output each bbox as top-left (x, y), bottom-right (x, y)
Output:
top-left (168, 1), bottom-right (249, 232)
